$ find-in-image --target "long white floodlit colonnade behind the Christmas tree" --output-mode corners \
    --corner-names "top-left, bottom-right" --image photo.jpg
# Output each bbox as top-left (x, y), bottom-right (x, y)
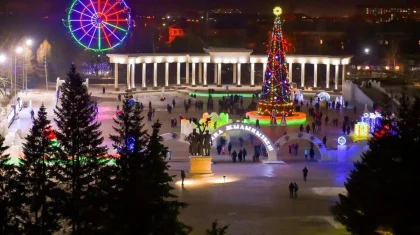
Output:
top-left (107, 48), bottom-right (351, 90)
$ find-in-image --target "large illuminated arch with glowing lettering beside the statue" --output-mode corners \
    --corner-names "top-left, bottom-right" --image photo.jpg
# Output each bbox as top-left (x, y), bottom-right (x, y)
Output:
top-left (211, 123), bottom-right (285, 164)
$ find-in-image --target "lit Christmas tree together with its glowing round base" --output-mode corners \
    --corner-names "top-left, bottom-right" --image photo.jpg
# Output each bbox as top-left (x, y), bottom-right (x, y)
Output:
top-left (246, 7), bottom-right (306, 126)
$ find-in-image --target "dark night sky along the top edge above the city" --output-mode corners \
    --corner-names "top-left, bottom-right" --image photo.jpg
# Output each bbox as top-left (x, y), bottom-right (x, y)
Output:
top-left (0, 0), bottom-right (420, 16)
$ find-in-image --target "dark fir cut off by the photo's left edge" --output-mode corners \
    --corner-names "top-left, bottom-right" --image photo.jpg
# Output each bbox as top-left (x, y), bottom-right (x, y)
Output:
top-left (0, 135), bottom-right (26, 235)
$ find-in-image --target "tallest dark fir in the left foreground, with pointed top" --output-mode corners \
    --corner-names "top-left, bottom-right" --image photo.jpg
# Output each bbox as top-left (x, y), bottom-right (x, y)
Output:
top-left (54, 65), bottom-right (107, 234)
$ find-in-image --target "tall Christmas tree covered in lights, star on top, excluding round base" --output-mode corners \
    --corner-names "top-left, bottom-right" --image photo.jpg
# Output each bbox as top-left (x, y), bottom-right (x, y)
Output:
top-left (258, 7), bottom-right (294, 116)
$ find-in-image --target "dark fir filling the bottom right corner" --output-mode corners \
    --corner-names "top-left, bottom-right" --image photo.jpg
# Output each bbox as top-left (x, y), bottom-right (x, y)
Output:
top-left (332, 94), bottom-right (420, 235)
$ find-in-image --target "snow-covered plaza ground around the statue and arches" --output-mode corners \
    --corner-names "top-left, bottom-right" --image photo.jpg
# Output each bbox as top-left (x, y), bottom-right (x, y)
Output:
top-left (0, 86), bottom-right (363, 235)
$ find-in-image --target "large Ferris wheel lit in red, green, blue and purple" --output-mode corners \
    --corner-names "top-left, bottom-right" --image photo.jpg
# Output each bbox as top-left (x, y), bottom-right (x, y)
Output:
top-left (65, 0), bottom-right (134, 52)
